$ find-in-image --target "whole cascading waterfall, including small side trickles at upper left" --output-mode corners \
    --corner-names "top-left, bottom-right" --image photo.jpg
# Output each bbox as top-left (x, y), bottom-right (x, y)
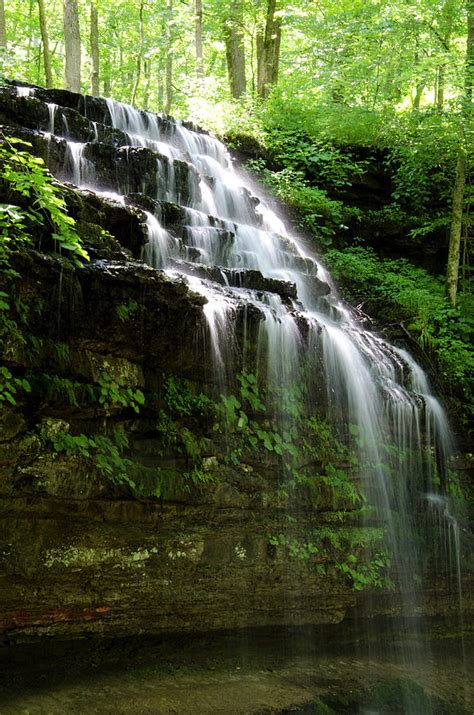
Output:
top-left (22, 86), bottom-right (466, 712)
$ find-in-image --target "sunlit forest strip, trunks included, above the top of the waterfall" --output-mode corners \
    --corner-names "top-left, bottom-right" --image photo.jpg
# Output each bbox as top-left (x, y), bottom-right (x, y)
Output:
top-left (0, 0), bottom-right (468, 118)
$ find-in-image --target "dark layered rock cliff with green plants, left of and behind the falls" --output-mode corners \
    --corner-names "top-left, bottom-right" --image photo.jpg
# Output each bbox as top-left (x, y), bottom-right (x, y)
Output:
top-left (0, 81), bottom-right (470, 643)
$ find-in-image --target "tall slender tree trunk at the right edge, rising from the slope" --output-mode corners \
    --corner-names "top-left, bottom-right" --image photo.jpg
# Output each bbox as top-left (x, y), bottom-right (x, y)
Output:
top-left (447, 0), bottom-right (474, 306)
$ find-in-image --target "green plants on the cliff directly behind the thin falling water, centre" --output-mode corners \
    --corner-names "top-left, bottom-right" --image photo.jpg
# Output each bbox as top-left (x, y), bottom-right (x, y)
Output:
top-left (218, 372), bottom-right (362, 508)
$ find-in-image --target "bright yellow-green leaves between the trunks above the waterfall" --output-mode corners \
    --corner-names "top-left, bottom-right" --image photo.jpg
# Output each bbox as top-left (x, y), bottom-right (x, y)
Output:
top-left (2, 0), bottom-right (465, 120)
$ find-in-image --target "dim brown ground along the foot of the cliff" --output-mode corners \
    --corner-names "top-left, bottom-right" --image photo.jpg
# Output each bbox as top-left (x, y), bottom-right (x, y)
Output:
top-left (0, 642), bottom-right (474, 715)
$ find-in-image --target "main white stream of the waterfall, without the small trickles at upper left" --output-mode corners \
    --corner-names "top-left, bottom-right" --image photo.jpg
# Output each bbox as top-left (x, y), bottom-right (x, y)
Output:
top-left (94, 102), bottom-right (458, 613)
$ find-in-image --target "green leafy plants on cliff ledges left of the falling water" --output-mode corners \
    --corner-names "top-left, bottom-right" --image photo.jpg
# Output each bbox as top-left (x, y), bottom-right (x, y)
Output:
top-left (40, 372), bottom-right (215, 498)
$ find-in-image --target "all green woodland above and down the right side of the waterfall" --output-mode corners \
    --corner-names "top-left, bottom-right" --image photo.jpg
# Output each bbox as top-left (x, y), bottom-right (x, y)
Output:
top-left (0, 0), bottom-right (474, 420)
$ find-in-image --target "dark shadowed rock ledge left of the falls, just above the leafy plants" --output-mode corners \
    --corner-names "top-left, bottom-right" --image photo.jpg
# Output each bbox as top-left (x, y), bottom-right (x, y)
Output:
top-left (3, 253), bottom-right (205, 376)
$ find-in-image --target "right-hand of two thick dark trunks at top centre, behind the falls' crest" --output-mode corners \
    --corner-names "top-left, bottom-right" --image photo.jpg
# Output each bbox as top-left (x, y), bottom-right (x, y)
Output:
top-left (257, 0), bottom-right (281, 97)
